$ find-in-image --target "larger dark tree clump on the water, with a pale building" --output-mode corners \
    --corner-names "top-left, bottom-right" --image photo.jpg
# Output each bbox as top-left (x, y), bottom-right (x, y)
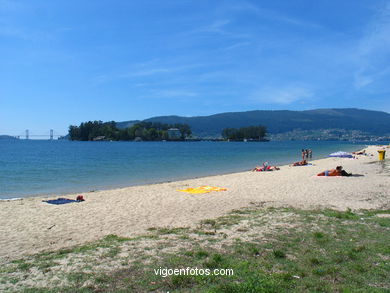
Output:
top-left (69, 121), bottom-right (192, 141)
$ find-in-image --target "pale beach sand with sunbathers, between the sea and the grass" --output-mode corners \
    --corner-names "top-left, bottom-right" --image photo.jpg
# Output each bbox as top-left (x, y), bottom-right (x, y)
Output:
top-left (0, 146), bottom-right (390, 263)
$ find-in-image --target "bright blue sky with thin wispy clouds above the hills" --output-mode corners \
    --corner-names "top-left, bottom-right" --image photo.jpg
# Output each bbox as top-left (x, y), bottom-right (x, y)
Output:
top-left (0, 0), bottom-right (390, 134)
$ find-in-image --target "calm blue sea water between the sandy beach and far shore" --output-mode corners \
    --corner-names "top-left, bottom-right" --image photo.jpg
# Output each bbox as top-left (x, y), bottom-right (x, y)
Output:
top-left (0, 140), bottom-right (376, 199)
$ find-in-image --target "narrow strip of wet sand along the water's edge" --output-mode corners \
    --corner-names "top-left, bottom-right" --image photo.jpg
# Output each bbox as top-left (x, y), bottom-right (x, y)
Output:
top-left (0, 145), bottom-right (374, 202)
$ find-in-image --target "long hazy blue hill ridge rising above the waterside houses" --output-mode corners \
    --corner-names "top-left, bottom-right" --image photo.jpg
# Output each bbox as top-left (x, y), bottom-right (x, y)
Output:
top-left (117, 108), bottom-right (390, 137)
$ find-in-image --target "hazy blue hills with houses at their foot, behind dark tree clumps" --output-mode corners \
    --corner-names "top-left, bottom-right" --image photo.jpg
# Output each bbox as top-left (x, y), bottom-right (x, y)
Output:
top-left (116, 108), bottom-right (390, 141)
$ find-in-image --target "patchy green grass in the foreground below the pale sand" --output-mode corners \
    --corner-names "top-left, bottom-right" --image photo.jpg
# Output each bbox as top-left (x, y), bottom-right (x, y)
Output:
top-left (0, 208), bottom-right (390, 292)
